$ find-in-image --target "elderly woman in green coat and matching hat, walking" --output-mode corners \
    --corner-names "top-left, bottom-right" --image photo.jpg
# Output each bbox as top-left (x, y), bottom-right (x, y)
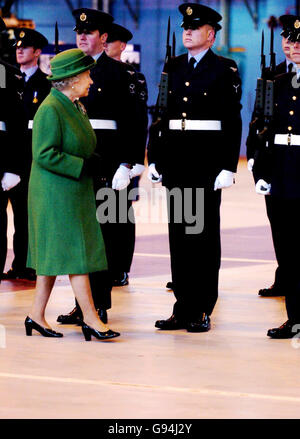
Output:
top-left (25, 49), bottom-right (120, 341)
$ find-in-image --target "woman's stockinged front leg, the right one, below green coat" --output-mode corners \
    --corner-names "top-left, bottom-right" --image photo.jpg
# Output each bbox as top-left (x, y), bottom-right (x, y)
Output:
top-left (69, 274), bottom-right (108, 332)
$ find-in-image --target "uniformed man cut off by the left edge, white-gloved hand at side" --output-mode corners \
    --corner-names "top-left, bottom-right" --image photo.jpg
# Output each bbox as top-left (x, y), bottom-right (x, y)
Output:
top-left (0, 18), bottom-right (27, 277)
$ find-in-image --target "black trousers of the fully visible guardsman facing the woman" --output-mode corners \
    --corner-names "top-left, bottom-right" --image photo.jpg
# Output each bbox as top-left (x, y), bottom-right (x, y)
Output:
top-left (168, 188), bottom-right (221, 320)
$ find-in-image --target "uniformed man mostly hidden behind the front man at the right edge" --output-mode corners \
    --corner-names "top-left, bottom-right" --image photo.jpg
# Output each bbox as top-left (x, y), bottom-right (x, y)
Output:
top-left (246, 15), bottom-right (297, 297)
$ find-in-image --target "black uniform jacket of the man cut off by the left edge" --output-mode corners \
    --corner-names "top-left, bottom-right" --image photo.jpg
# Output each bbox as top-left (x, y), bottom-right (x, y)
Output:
top-left (0, 60), bottom-right (26, 180)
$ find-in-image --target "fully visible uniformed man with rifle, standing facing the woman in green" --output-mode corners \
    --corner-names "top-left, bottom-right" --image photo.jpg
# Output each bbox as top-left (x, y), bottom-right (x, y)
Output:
top-left (148, 3), bottom-right (241, 332)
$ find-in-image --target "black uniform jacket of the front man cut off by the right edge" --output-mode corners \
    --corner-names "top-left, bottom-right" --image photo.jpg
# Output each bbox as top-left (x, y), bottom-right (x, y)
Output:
top-left (259, 73), bottom-right (300, 199)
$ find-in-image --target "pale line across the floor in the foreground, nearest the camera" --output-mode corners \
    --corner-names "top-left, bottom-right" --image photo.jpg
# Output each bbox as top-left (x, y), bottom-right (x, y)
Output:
top-left (0, 372), bottom-right (300, 403)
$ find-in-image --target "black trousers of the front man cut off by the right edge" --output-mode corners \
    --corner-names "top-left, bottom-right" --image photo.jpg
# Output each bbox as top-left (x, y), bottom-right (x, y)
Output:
top-left (271, 195), bottom-right (300, 323)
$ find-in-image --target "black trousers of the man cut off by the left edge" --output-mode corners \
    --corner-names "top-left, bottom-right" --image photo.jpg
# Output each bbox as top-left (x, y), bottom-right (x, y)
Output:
top-left (0, 178), bottom-right (28, 273)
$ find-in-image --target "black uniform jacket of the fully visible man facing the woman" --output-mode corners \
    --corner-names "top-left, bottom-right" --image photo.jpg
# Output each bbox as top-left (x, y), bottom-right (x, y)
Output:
top-left (148, 50), bottom-right (241, 187)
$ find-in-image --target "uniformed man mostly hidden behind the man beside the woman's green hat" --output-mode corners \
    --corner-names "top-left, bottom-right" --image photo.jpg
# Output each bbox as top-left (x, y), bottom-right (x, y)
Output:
top-left (105, 23), bottom-right (148, 287)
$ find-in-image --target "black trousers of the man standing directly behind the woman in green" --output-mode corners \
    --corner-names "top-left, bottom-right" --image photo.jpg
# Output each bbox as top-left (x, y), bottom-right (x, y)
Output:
top-left (77, 180), bottom-right (135, 309)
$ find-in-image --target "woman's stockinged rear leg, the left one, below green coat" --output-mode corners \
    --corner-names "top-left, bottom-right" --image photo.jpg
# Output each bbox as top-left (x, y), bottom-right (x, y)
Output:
top-left (29, 276), bottom-right (56, 328)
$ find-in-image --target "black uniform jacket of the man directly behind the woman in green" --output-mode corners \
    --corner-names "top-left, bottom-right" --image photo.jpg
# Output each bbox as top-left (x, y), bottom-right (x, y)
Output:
top-left (81, 52), bottom-right (141, 179)
